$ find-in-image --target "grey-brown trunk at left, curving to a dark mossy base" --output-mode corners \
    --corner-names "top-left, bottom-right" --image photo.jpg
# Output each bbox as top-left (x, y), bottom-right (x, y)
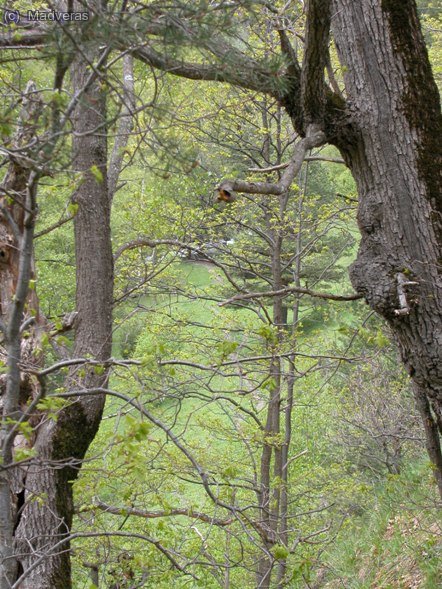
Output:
top-left (16, 41), bottom-right (113, 589)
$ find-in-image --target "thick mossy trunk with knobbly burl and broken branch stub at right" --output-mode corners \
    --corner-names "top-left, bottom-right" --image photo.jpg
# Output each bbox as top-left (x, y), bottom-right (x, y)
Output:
top-left (332, 0), bottom-right (442, 496)
